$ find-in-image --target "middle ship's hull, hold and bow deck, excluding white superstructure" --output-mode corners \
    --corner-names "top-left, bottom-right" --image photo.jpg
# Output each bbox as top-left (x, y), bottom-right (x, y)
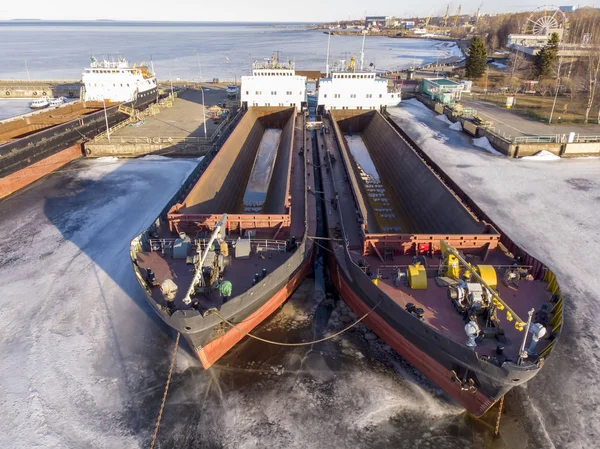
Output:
top-left (130, 103), bottom-right (316, 369)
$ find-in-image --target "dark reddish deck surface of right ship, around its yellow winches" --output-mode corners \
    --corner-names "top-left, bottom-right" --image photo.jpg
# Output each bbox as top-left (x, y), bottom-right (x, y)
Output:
top-left (318, 112), bottom-right (552, 360)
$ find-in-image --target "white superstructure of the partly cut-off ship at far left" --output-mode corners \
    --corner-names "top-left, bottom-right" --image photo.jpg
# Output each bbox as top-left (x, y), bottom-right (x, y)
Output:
top-left (81, 57), bottom-right (156, 102)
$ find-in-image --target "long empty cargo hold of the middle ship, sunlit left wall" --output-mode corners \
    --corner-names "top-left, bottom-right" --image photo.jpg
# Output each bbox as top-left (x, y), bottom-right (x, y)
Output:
top-left (178, 107), bottom-right (295, 214)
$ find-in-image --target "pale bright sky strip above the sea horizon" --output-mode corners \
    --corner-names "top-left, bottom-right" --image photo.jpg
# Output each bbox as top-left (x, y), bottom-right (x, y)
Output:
top-left (0, 0), bottom-right (600, 22)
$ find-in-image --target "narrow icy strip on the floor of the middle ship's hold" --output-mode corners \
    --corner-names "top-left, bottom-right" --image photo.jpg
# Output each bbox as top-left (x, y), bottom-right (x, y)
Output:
top-left (242, 128), bottom-right (281, 212)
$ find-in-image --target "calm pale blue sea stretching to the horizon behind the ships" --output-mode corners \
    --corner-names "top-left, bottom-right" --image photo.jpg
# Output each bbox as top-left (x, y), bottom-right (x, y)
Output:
top-left (0, 22), bottom-right (460, 80)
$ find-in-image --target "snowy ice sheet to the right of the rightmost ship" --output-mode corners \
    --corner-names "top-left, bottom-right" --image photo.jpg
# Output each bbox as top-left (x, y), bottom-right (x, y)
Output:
top-left (388, 100), bottom-right (600, 449)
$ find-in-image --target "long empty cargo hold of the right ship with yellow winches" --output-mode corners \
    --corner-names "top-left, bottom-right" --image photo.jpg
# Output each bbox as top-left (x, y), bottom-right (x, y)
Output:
top-left (331, 110), bottom-right (485, 234)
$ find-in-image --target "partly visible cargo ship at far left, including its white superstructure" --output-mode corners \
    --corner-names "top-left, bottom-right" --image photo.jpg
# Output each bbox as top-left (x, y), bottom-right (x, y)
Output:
top-left (0, 58), bottom-right (158, 199)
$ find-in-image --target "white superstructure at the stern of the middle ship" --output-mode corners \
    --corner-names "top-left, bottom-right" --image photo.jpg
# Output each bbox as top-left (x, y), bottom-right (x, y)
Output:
top-left (241, 56), bottom-right (306, 110)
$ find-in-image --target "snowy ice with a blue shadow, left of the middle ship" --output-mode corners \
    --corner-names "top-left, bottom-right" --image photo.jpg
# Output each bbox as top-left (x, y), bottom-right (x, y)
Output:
top-left (0, 158), bottom-right (197, 449)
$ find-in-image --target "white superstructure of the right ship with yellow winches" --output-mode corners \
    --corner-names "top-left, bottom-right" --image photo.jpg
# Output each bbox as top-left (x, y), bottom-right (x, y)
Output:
top-left (318, 58), bottom-right (400, 111)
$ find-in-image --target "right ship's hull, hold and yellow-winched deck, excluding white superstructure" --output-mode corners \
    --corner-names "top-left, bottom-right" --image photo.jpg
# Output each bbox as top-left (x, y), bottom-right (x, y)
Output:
top-left (318, 109), bottom-right (563, 417)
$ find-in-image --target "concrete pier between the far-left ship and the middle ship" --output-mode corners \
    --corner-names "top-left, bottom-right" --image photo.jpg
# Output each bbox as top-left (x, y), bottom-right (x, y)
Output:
top-left (84, 85), bottom-right (234, 157)
